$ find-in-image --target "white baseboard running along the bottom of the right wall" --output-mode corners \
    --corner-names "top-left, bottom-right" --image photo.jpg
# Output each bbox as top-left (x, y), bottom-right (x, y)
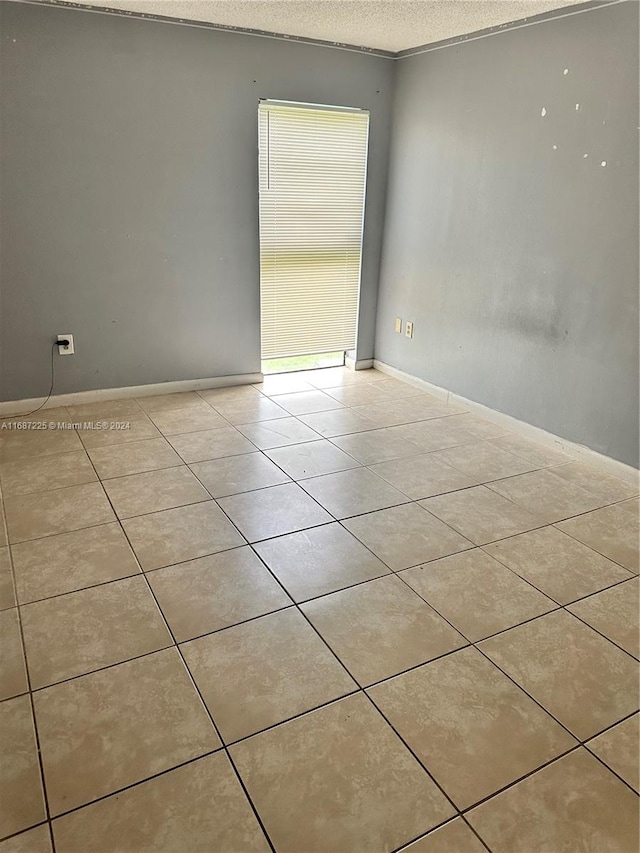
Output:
top-left (373, 359), bottom-right (640, 486)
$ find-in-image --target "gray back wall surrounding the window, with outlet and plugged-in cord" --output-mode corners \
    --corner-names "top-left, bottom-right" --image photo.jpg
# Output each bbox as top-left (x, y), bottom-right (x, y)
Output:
top-left (0, 3), bottom-right (395, 400)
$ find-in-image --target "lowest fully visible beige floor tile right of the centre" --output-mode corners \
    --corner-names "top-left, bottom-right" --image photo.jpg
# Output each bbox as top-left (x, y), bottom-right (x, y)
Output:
top-left (367, 648), bottom-right (576, 809)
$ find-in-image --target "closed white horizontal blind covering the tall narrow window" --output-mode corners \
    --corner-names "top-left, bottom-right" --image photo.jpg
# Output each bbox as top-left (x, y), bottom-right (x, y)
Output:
top-left (259, 101), bottom-right (369, 359)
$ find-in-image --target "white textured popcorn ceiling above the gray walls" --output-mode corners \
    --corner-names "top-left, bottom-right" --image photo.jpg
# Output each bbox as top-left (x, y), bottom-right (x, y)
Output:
top-left (65, 0), bottom-right (582, 53)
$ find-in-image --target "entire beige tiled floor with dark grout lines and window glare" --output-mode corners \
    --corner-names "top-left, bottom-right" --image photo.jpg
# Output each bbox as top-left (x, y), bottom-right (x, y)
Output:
top-left (0, 368), bottom-right (639, 853)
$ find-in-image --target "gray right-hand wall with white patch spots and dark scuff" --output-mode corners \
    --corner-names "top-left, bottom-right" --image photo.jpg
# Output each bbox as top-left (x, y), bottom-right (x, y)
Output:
top-left (376, 2), bottom-right (639, 465)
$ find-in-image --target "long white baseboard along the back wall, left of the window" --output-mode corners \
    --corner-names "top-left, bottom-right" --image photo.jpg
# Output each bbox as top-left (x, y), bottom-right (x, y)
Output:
top-left (0, 373), bottom-right (264, 417)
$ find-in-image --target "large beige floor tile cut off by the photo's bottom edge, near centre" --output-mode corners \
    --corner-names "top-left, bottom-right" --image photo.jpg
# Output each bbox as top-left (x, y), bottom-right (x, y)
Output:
top-left (230, 694), bottom-right (453, 853)
